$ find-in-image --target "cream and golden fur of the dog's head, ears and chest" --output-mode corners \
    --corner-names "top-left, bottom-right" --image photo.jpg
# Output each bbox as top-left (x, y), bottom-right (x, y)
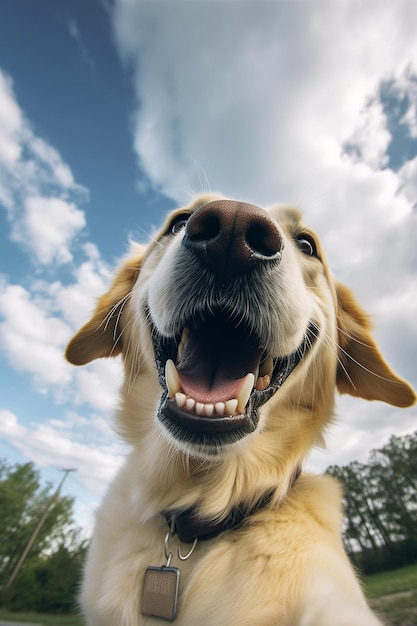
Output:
top-left (67, 196), bottom-right (415, 626)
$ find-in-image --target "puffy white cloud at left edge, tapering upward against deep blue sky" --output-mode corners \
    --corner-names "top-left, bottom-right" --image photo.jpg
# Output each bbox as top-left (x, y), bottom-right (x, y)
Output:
top-left (0, 70), bottom-right (88, 265)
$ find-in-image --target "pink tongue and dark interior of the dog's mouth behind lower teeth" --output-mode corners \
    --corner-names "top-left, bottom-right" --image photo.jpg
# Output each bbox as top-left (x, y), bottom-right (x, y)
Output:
top-left (177, 321), bottom-right (263, 404)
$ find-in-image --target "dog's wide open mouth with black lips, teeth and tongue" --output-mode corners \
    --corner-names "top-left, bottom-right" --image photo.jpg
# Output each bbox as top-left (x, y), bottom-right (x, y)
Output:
top-left (152, 313), bottom-right (317, 449)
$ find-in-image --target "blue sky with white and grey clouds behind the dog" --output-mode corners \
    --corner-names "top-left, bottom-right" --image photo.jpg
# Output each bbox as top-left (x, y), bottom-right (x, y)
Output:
top-left (0, 0), bottom-right (417, 532)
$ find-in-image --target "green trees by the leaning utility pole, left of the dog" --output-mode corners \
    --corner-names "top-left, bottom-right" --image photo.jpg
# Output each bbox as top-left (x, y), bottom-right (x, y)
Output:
top-left (0, 461), bottom-right (86, 612)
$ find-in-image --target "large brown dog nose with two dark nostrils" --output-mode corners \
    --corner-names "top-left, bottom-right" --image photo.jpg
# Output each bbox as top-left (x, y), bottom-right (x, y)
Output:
top-left (183, 200), bottom-right (283, 278)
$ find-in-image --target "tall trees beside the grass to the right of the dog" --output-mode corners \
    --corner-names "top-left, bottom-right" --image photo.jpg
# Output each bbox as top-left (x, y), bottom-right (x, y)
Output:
top-left (328, 432), bottom-right (417, 570)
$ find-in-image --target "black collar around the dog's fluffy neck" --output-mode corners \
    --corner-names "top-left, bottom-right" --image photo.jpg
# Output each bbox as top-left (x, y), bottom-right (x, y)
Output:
top-left (162, 467), bottom-right (301, 543)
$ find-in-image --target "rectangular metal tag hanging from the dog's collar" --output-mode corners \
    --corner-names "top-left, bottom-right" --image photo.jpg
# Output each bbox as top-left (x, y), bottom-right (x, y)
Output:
top-left (141, 566), bottom-right (180, 622)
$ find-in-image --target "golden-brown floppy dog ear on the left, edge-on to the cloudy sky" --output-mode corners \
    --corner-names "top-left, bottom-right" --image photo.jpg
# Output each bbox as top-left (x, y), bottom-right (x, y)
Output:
top-left (65, 244), bottom-right (146, 365)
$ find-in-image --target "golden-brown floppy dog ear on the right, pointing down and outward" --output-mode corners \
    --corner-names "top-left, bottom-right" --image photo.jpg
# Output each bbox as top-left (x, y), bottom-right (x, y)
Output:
top-left (336, 283), bottom-right (416, 407)
